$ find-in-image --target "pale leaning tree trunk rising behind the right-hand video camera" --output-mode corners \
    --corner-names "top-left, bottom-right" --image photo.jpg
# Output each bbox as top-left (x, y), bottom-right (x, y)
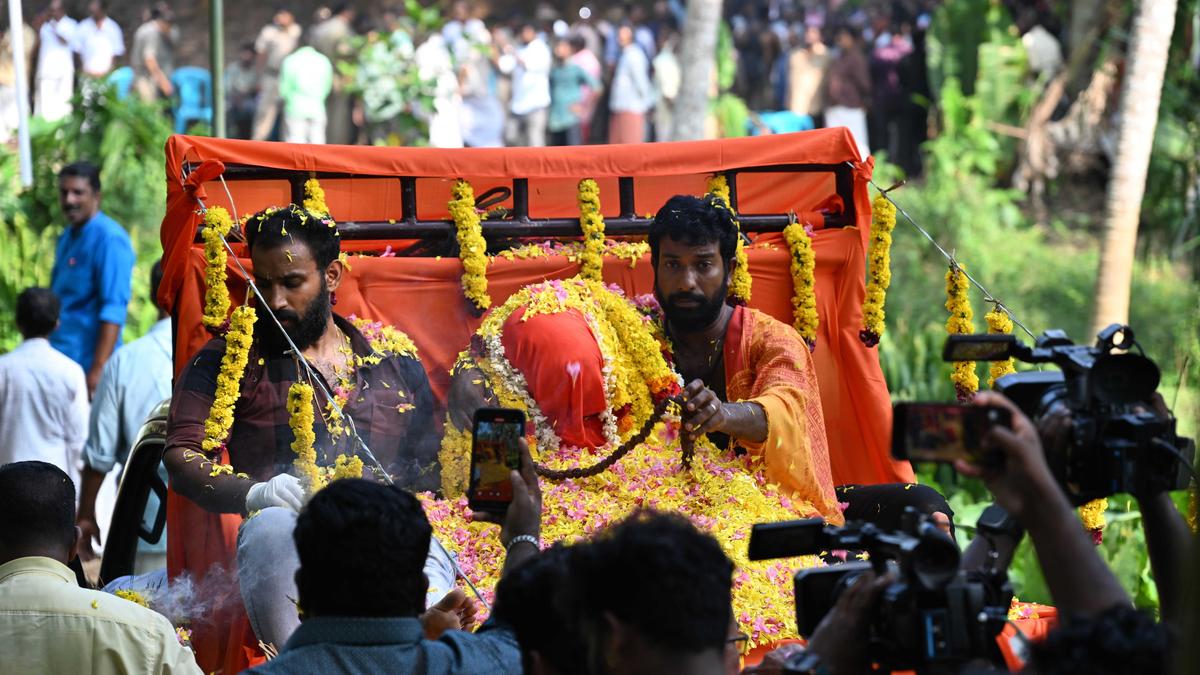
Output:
top-left (1092, 0), bottom-right (1176, 333)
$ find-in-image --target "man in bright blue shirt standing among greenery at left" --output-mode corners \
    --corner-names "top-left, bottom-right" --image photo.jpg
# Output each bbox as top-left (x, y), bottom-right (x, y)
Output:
top-left (50, 162), bottom-right (133, 396)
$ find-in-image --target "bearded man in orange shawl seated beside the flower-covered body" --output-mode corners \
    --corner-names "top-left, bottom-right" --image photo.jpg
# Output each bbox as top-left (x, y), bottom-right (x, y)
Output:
top-left (649, 195), bottom-right (952, 528)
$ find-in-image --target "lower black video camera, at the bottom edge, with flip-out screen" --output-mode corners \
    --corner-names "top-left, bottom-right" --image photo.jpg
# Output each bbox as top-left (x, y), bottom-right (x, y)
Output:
top-left (750, 507), bottom-right (1013, 673)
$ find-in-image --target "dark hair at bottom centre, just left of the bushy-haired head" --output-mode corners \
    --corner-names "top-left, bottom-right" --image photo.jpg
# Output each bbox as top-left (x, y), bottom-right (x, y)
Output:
top-left (492, 544), bottom-right (587, 674)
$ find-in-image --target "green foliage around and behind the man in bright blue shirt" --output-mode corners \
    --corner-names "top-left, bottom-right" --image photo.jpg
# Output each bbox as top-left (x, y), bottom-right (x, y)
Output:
top-left (0, 86), bottom-right (172, 353)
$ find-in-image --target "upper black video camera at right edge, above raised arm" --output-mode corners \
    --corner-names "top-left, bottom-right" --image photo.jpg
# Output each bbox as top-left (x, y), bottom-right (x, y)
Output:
top-left (942, 323), bottom-right (1195, 504)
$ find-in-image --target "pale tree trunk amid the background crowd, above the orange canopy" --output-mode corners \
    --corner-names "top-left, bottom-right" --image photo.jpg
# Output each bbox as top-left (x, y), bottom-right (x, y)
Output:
top-left (671, 0), bottom-right (721, 141)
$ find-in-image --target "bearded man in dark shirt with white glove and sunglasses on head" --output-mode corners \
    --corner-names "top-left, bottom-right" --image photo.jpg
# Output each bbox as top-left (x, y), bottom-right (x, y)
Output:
top-left (163, 205), bottom-right (454, 646)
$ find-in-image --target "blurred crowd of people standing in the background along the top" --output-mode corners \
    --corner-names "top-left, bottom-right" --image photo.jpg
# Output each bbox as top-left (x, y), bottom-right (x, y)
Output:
top-left (0, 0), bottom-right (1062, 173)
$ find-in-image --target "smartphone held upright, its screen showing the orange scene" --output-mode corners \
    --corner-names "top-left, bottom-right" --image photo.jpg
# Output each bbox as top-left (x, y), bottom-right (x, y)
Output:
top-left (467, 408), bottom-right (524, 513)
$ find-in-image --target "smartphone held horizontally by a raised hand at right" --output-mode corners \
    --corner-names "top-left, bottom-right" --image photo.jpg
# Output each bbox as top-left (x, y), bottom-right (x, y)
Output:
top-left (892, 404), bottom-right (1013, 464)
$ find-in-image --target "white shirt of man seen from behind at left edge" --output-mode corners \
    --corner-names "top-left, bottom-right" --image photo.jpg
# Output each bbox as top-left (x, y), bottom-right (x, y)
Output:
top-left (0, 338), bottom-right (88, 485)
